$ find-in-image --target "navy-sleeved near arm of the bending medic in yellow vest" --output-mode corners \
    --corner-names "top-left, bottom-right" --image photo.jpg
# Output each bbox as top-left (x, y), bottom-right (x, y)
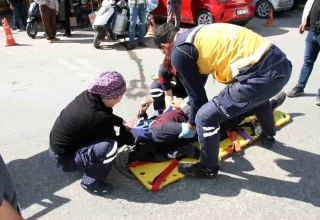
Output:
top-left (171, 44), bottom-right (208, 127)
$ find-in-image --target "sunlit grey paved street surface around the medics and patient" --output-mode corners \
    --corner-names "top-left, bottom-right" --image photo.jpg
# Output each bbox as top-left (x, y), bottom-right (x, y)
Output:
top-left (0, 13), bottom-right (320, 219)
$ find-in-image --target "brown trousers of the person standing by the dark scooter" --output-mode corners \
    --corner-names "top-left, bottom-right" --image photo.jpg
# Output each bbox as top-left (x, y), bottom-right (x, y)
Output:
top-left (40, 5), bottom-right (57, 39)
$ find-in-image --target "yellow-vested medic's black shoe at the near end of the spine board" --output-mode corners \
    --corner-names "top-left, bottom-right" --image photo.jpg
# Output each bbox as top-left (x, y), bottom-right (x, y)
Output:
top-left (178, 163), bottom-right (219, 179)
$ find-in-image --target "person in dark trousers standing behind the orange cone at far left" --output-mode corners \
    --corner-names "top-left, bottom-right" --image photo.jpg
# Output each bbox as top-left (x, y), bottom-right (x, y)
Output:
top-left (7, 0), bottom-right (27, 31)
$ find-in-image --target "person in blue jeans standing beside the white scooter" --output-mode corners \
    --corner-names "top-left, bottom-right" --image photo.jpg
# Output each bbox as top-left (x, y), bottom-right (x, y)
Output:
top-left (127, 0), bottom-right (147, 50)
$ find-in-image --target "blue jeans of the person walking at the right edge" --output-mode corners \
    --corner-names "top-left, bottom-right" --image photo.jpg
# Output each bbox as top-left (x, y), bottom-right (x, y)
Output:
top-left (298, 31), bottom-right (320, 95)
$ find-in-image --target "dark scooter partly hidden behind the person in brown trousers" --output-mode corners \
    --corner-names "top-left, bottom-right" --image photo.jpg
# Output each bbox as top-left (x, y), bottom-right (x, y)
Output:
top-left (26, 2), bottom-right (41, 38)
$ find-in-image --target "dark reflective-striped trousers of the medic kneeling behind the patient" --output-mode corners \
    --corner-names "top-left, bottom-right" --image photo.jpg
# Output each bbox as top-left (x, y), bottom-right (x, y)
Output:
top-left (149, 75), bottom-right (208, 113)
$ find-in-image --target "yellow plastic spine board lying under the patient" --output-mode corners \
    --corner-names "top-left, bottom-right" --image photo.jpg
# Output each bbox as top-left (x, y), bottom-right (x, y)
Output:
top-left (130, 110), bottom-right (290, 190)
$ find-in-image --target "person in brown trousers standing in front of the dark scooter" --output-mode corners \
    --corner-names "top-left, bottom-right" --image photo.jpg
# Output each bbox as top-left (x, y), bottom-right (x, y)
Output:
top-left (34, 0), bottom-right (60, 43)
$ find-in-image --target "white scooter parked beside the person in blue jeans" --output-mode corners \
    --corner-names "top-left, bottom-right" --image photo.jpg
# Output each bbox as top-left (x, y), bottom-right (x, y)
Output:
top-left (93, 0), bottom-right (152, 48)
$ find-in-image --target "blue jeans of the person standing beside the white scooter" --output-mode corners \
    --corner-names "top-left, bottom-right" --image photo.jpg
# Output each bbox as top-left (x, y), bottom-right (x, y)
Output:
top-left (129, 4), bottom-right (146, 43)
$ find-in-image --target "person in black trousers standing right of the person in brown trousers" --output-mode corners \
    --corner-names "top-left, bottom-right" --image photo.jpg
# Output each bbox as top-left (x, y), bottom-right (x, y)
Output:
top-left (59, 0), bottom-right (73, 37)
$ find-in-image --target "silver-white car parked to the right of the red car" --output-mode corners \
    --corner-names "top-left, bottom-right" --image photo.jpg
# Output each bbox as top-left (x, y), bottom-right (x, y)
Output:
top-left (254, 0), bottom-right (294, 18)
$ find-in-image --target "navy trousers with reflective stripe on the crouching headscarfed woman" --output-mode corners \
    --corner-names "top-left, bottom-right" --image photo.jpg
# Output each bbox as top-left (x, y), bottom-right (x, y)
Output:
top-left (49, 139), bottom-right (118, 181)
